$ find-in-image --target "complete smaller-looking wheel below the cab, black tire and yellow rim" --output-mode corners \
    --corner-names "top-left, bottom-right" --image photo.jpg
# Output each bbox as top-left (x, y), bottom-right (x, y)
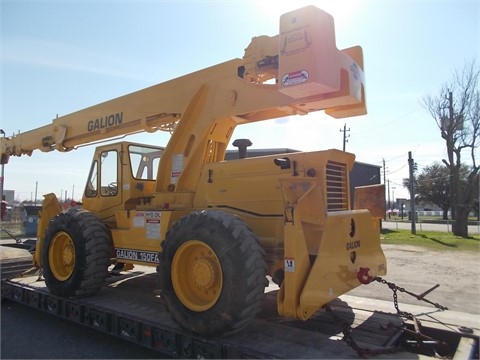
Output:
top-left (41, 209), bottom-right (112, 297)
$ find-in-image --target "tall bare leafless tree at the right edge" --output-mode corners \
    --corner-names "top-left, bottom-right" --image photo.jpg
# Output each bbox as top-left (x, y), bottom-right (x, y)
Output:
top-left (423, 61), bottom-right (480, 237)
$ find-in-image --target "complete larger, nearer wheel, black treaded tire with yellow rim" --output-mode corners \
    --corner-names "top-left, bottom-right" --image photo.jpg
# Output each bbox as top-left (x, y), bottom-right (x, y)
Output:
top-left (158, 210), bottom-right (268, 336)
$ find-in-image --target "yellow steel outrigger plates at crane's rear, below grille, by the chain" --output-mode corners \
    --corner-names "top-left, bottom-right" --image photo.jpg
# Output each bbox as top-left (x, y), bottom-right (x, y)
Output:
top-left (278, 210), bottom-right (387, 320)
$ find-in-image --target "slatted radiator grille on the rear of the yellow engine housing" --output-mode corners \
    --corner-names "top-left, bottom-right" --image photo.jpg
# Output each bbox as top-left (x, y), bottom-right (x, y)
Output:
top-left (326, 161), bottom-right (348, 211)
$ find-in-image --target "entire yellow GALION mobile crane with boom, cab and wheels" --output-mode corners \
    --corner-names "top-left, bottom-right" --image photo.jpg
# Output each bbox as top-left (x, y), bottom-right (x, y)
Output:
top-left (0, 6), bottom-right (386, 335)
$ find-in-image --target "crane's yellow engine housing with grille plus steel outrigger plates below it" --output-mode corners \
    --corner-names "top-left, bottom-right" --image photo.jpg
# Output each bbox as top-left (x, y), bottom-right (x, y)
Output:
top-left (195, 149), bottom-right (386, 320)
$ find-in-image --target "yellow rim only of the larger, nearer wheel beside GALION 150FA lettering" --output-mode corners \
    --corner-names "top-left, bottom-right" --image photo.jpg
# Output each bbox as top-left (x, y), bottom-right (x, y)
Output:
top-left (172, 240), bottom-right (223, 311)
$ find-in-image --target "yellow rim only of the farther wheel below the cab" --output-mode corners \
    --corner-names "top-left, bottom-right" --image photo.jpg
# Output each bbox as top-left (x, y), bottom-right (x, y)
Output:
top-left (48, 231), bottom-right (75, 281)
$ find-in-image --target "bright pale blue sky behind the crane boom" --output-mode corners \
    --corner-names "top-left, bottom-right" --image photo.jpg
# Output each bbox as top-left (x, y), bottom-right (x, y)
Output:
top-left (0, 0), bottom-right (480, 200)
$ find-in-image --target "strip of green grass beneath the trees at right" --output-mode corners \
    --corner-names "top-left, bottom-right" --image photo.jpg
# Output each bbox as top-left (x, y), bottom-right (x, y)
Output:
top-left (380, 229), bottom-right (480, 253)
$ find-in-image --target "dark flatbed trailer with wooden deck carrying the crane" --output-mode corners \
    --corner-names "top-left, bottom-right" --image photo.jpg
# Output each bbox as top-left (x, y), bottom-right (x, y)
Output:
top-left (1, 266), bottom-right (480, 359)
